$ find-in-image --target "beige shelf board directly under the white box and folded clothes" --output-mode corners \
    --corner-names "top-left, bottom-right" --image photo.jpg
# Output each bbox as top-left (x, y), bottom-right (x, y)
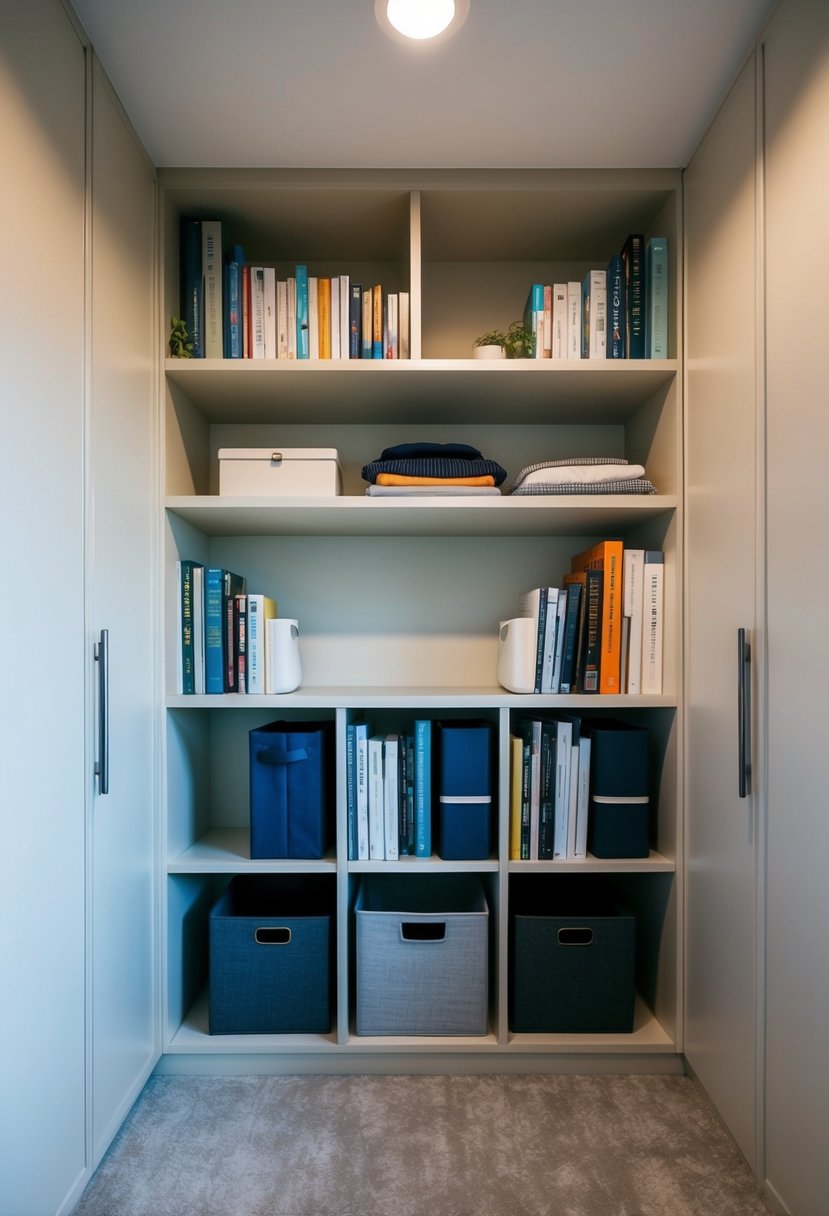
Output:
top-left (167, 494), bottom-right (677, 536)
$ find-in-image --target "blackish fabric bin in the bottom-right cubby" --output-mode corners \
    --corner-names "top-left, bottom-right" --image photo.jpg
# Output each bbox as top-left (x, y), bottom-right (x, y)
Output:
top-left (509, 879), bottom-right (636, 1034)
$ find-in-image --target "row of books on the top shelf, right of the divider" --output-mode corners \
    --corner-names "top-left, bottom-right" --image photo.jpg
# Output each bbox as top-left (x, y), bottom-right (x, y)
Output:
top-left (524, 232), bottom-right (669, 359)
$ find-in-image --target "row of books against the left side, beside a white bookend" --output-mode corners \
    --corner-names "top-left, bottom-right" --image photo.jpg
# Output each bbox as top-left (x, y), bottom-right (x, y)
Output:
top-left (176, 558), bottom-right (278, 694)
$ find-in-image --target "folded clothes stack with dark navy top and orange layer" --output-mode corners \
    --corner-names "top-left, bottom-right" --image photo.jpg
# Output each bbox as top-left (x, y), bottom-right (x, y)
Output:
top-left (362, 443), bottom-right (507, 497)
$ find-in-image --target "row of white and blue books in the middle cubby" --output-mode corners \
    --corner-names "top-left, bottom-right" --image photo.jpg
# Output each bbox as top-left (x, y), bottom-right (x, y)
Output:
top-left (345, 719), bottom-right (432, 861)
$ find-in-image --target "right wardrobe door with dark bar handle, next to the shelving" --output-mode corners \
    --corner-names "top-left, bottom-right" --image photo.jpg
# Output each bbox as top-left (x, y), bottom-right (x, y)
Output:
top-left (684, 60), bottom-right (758, 1165)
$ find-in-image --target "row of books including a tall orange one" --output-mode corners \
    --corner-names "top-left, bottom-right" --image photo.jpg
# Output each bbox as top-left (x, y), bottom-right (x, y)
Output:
top-left (518, 539), bottom-right (665, 694)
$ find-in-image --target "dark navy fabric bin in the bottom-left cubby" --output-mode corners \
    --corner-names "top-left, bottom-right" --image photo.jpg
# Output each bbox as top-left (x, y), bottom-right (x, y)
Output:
top-left (209, 874), bottom-right (334, 1035)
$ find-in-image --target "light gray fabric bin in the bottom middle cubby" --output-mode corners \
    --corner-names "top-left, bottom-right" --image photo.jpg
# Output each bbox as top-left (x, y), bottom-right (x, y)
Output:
top-left (355, 874), bottom-right (489, 1035)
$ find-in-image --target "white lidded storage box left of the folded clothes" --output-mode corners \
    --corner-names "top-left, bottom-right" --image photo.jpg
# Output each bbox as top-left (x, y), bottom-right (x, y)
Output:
top-left (219, 447), bottom-right (343, 497)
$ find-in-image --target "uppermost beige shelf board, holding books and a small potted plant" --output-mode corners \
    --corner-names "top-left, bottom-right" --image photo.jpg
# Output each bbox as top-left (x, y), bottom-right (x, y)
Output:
top-left (165, 359), bottom-right (677, 423)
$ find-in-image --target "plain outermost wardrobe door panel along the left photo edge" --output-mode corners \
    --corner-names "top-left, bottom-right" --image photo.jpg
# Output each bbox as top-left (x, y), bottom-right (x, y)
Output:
top-left (0, 0), bottom-right (85, 1216)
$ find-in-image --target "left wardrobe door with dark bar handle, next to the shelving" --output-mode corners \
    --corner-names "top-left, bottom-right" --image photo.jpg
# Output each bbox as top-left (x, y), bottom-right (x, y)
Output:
top-left (90, 61), bottom-right (159, 1165)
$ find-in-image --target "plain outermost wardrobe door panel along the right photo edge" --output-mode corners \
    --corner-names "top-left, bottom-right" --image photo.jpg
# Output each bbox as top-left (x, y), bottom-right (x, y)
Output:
top-left (765, 0), bottom-right (829, 1216)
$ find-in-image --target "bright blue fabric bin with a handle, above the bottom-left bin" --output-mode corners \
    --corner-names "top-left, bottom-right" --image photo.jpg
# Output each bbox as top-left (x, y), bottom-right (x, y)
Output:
top-left (249, 721), bottom-right (334, 858)
